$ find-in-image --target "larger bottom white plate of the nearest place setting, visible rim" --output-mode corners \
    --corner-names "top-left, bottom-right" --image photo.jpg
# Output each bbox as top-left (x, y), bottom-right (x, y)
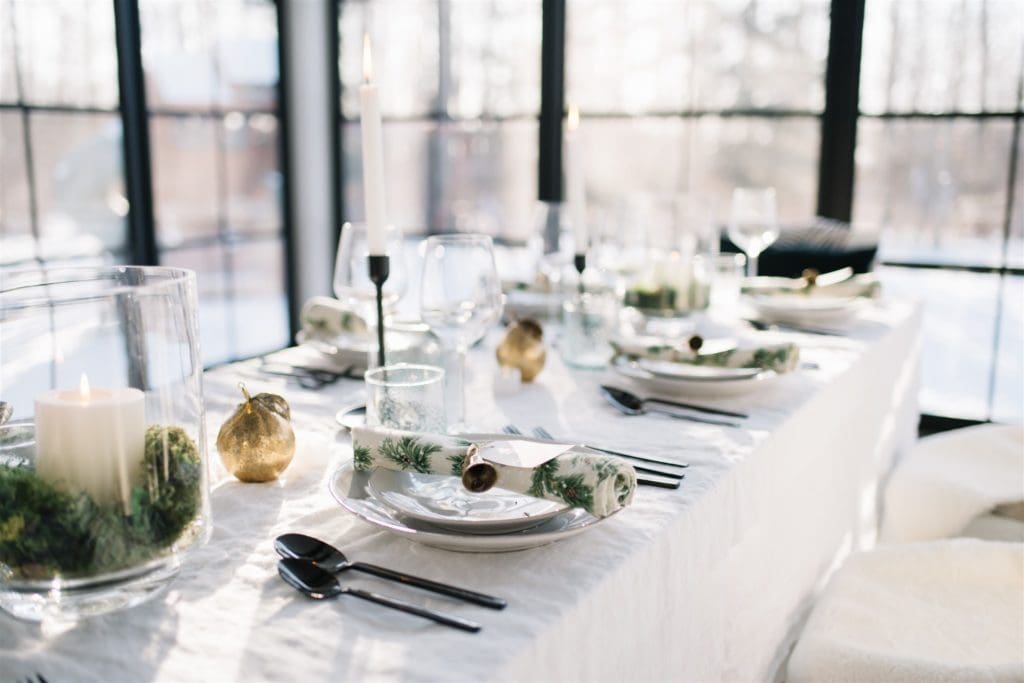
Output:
top-left (328, 463), bottom-right (617, 553)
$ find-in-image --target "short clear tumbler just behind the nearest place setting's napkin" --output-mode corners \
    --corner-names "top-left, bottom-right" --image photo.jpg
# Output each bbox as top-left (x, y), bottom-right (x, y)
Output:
top-left (366, 362), bottom-right (445, 434)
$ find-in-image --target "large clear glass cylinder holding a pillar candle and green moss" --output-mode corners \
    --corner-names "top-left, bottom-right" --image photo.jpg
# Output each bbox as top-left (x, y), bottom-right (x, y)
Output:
top-left (0, 267), bottom-right (211, 621)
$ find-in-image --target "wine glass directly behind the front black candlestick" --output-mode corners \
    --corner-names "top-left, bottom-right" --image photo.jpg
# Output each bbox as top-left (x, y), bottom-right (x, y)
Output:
top-left (334, 222), bottom-right (406, 350)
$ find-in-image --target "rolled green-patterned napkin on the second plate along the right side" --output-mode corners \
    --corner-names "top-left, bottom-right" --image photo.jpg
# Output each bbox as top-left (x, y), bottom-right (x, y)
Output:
top-left (610, 338), bottom-right (800, 374)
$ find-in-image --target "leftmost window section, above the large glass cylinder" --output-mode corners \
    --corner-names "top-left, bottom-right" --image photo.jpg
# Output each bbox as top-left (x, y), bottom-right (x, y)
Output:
top-left (0, 0), bottom-right (128, 267)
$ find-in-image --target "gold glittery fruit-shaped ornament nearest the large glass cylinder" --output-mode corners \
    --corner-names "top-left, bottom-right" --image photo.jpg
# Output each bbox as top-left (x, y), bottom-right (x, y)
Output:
top-left (217, 382), bottom-right (295, 481)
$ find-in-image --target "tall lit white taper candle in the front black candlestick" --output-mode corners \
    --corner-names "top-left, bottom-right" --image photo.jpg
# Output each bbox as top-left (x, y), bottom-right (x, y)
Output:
top-left (359, 35), bottom-right (387, 256)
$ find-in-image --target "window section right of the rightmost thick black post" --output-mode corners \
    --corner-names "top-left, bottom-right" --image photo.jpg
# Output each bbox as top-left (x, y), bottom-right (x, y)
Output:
top-left (854, 0), bottom-right (1024, 422)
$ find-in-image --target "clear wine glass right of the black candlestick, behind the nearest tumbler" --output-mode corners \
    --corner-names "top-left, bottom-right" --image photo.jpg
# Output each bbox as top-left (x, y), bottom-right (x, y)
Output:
top-left (420, 234), bottom-right (502, 431)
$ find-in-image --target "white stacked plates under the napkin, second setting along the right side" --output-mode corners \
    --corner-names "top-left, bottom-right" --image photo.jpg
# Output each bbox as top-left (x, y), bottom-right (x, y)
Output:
top-left (611, 356), bottom-right (779, 398)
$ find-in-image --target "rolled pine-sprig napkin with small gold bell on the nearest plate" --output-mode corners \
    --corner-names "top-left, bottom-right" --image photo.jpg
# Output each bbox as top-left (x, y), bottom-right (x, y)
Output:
top-left (352, 427), bottom-right (637, 517)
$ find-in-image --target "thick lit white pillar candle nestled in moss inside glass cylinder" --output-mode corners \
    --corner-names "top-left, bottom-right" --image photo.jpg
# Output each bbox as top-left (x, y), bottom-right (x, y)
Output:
top-left (35, 375), bottom-right (145, 514)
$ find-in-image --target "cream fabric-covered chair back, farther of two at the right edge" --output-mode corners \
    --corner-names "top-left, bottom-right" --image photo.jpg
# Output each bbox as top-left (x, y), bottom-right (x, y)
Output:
top-left (881, 425), bottom-right (1024, 543)
